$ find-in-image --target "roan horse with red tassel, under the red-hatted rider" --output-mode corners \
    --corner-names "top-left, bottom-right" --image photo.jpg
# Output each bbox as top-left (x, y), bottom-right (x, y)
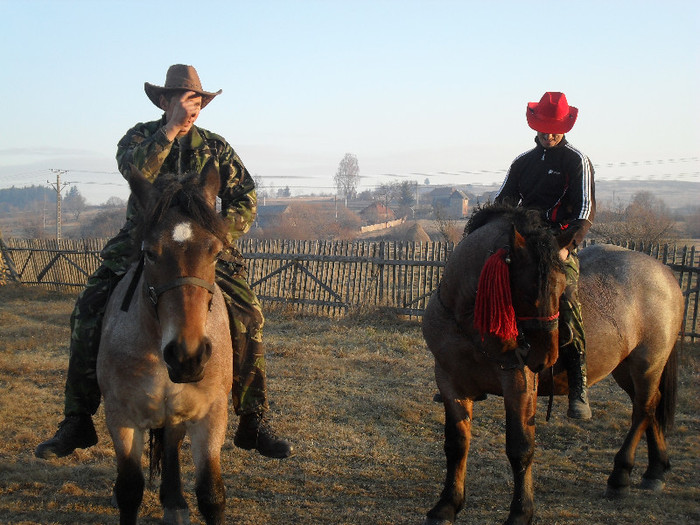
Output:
top-left (423, 205), bottom-right (683, 525)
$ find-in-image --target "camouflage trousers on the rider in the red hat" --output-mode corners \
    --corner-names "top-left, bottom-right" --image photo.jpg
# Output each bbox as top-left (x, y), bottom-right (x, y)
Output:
top-left (559, 249), bottom-right (586, 387)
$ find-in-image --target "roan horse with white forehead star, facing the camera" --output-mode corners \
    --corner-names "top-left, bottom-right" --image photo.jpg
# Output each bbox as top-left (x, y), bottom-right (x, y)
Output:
top-left (97, 166), bottom-right (233, 524)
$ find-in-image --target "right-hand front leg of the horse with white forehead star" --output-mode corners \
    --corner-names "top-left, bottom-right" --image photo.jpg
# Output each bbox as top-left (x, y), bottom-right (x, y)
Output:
top-left (190, 398), bottom-right (228, 525)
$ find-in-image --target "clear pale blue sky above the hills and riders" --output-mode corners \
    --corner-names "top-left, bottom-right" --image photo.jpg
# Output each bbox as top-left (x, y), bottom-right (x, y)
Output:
top-left (0, 0), bottom-right (700, 204)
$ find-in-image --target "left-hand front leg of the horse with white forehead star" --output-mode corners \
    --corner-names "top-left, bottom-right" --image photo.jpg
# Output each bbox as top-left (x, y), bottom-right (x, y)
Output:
top-left (108, 421), bottom-right (145, 525)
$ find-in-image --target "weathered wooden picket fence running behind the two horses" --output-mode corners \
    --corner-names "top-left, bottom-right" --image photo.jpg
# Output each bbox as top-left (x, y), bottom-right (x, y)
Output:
top-left (0, 239), bottom-right (700, 341)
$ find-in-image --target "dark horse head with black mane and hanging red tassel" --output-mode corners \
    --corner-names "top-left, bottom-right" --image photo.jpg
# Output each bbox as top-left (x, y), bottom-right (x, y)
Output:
top-left (468, 206), bottom-right (566, 373)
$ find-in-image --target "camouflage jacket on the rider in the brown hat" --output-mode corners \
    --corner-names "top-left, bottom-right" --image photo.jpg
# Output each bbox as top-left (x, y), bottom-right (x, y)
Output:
top-left (117, 115), bottom-right (257, 241)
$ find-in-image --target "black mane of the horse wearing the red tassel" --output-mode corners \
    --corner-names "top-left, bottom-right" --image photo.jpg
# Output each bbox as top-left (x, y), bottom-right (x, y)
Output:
top-left (464, 203), bottom-right (564, 297)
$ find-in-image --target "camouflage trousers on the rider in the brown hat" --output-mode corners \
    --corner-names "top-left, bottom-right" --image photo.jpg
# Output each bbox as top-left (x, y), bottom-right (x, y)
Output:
top-left (64, 226), bottom-right (268, 416)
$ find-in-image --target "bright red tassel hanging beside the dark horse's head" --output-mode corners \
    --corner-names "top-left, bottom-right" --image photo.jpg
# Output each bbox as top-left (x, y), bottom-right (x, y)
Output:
top-left (474, 248), bottom-right (518, 340)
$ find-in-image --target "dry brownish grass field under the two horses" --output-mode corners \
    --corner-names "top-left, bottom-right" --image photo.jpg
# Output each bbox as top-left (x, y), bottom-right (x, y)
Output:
top-left (0, 286), bottom-right (700, 525)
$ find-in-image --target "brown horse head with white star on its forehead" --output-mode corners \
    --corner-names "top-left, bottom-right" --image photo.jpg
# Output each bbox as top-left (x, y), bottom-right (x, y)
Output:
top-left (123, 162), bottom-right (227, 383)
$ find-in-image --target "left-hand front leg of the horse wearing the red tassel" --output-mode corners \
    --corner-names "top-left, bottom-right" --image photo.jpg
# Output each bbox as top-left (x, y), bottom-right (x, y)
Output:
top-left (424, 365), bottom-right (474, 525)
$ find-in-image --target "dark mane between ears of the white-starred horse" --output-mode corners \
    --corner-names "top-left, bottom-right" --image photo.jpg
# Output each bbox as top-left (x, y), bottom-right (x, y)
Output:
top-left (136, 173), bottom-right (228, 248)
